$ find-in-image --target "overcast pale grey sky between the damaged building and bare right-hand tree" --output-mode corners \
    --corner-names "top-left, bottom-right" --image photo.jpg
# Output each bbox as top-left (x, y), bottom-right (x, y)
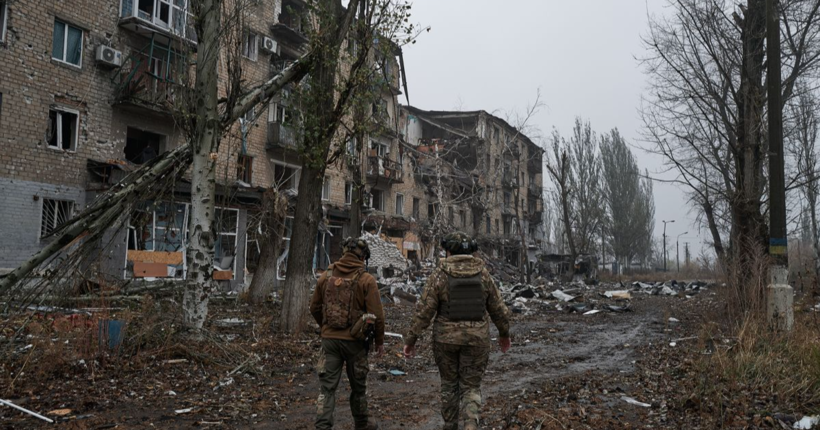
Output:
top-left (402, 0), bottom-right (708, 259)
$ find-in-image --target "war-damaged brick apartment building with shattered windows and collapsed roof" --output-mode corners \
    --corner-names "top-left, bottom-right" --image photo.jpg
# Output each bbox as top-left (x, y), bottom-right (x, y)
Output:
top-left (0, 0), bottom-right (543, 290)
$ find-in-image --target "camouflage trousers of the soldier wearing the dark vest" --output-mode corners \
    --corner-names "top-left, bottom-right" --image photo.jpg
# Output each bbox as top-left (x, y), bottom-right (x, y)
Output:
top-left (433, 342), bottom-right (490, 430)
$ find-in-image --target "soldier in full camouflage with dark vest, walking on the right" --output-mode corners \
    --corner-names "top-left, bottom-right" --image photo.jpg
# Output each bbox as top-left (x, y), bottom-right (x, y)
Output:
top-left (404, 232), bottom-right (510, 430)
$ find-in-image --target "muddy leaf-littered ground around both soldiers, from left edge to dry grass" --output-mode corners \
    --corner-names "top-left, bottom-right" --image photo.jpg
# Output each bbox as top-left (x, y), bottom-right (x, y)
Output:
top-left (0, 287), bottom-right (714, 430)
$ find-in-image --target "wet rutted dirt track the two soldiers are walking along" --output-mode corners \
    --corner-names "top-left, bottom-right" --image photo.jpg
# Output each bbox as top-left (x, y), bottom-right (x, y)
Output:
top-left (262, 297), bottom-right (672, 430)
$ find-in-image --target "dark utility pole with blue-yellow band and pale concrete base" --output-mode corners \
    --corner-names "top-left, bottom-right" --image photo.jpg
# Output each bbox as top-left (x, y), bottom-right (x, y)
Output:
top-left (766, 0), bottom-right (794, 330)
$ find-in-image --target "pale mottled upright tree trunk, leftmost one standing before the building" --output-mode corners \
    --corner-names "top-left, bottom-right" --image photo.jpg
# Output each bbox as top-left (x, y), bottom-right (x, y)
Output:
top-left (182, 0), bottom-right (222, 331)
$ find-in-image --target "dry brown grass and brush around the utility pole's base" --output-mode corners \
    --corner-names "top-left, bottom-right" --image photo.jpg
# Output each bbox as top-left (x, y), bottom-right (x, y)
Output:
top-left (696, 245), bottom-right (820, 423)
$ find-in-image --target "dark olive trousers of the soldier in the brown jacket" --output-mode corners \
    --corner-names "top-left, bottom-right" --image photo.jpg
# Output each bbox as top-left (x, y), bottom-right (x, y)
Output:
top-left (316, 339), bottom-right (369, 430)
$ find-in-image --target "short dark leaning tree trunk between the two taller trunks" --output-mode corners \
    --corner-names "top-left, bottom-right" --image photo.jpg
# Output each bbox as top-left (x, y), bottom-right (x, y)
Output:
top-left (248, 188), bottom-right (288, 303)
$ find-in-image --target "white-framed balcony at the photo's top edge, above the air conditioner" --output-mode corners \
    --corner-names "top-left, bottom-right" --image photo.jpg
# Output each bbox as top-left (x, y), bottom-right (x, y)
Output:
top-left (119, 0), bottom-right (197, 44)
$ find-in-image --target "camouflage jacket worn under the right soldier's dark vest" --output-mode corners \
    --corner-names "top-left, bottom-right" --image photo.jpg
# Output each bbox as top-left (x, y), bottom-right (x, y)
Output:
top-left (405, 255), bottom-right (510, 346)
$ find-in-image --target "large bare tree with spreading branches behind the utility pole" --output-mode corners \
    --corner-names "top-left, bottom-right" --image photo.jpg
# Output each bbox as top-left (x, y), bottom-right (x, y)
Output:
top-left (642, 0), bottom-right (820, 278)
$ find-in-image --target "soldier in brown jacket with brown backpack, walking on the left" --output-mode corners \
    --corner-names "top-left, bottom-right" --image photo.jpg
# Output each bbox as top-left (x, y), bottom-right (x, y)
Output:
top-left (310, 238), bottom-right (384, 430)
